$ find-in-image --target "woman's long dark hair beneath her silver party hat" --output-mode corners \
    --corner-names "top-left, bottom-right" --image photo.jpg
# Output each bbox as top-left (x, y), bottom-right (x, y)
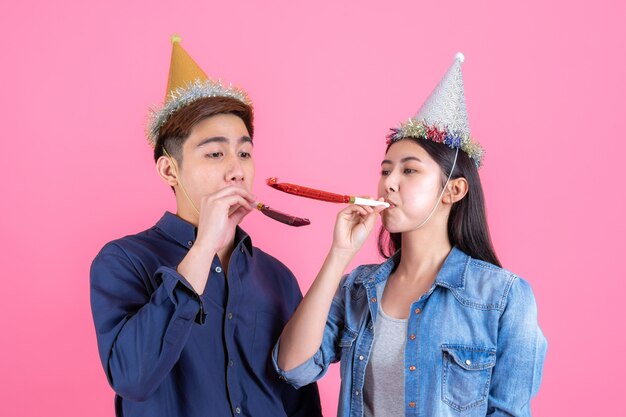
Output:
top-left (378, 138), bottom-right (502, 266)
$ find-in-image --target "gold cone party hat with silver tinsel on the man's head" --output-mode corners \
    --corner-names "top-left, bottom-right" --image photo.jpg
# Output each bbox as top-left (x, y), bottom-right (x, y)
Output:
top-left (146, 35), bottom-right (252, 147)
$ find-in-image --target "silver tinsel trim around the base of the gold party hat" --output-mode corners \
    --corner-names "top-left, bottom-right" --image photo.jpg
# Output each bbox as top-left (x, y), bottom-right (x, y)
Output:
top-left (146, 79), bottom-right (252, 147)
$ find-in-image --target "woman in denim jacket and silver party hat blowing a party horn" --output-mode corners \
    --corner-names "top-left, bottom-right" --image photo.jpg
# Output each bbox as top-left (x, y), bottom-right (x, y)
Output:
top-left (273, 54), bottom-right (546, 417)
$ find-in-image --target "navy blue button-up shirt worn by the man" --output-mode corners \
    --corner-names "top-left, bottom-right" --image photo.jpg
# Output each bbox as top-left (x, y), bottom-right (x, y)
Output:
top-left (91, 212), bottom-right (322, 417)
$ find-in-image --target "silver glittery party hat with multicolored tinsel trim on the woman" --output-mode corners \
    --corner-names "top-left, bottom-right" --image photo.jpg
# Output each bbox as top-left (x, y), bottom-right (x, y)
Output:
top-left (389, 52), bottom-right (484, 167)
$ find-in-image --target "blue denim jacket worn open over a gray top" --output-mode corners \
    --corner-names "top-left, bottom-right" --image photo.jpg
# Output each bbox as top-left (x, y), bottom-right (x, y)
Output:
top-left (272, 248), bottom-right (547, 417)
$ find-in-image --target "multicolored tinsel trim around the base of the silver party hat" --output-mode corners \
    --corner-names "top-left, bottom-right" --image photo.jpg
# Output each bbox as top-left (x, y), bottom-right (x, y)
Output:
top-left (387, 118), bottom-right (485, 168)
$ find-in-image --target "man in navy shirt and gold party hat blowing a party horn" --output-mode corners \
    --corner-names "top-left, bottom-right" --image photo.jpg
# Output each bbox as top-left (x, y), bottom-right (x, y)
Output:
top-left (91, 38), bottom-right (321, 417)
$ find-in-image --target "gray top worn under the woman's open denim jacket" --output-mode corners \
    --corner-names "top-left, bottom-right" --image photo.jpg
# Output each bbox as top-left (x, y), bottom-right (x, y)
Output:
top-left (363, 282), bottom-right (408, 417)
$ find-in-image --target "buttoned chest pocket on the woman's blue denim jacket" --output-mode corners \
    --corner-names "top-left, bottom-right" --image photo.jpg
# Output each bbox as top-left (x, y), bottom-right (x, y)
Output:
top-left (441, 345), bottom-right (496, 412)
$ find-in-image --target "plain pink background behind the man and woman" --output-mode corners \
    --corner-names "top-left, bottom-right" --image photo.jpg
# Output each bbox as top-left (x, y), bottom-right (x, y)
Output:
top-left (0, 0), bottom-right (626, 417)
